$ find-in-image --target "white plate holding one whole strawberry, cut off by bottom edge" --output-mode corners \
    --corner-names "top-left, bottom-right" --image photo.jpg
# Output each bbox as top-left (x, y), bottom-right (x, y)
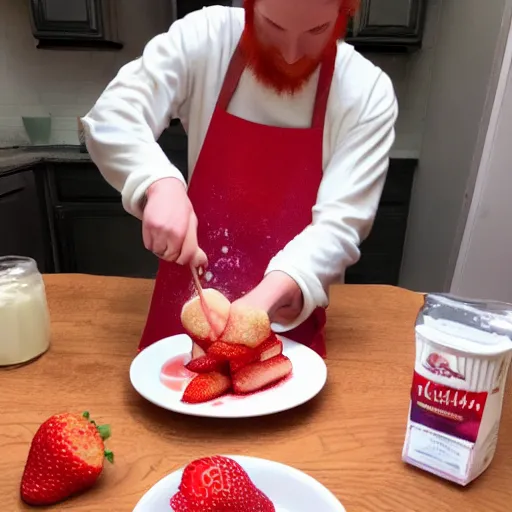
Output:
top-left (133, 455), bottom-right (346, 512)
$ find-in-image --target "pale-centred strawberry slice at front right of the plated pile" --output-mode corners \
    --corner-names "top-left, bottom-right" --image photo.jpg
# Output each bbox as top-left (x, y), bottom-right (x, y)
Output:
top-left (233, 354), bottom-right (292, 394)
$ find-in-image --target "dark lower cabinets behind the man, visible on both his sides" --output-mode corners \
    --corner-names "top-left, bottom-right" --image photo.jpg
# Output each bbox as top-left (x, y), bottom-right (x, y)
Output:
top-left (0, 150), bottom-right (417, 285)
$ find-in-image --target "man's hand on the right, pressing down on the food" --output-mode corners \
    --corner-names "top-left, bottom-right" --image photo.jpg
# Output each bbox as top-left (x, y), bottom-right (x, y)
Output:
top-left (236, 271), bottom-right (304, 324)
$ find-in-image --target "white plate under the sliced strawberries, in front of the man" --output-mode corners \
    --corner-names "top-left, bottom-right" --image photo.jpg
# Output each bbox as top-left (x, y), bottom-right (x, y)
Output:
top-left (130, 334), bottom-right (327, 418)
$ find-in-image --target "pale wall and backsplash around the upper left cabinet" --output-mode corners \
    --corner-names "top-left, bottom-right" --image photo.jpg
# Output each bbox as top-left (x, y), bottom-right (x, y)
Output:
top-left (0, 0), bottom-right (171, 147)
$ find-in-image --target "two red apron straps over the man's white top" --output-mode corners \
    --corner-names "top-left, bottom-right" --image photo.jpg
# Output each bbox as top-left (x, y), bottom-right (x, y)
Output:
top-left (216, 43), bottom-right (337, 130)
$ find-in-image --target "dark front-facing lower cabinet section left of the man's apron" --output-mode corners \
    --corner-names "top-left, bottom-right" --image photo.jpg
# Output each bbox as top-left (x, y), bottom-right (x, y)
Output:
top-left (46, 162), bottom-right (158, 277)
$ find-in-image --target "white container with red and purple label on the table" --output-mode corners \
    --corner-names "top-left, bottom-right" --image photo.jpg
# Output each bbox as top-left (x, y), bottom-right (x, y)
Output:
top-left (403, 294), bottom-right (512, 485)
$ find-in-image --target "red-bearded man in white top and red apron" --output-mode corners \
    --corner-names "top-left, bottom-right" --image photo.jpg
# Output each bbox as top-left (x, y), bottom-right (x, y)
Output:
top-left (83, 0), bottom-right (398, 355)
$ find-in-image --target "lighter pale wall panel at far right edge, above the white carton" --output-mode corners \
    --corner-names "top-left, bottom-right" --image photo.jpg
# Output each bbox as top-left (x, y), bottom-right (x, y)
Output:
top-left (451, 18), bottom-right (512, 302)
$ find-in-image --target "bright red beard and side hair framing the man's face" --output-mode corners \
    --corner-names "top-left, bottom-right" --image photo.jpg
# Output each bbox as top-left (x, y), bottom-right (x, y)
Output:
top-left (240, 0), bottom-right (354, 94)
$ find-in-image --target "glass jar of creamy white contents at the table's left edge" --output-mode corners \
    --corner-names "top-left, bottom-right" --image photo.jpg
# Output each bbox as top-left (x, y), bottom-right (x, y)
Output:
top-left (0, 256), bottom-right (50, 366)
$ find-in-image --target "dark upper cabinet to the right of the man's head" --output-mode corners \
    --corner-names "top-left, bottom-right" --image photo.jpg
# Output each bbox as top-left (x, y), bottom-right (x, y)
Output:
top-left (347, 0), bottom-right (427, 52)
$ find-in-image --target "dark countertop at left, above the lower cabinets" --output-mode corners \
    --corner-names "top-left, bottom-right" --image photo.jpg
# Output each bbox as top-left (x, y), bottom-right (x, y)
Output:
top-left (0, 146), bottom-right (91, 174)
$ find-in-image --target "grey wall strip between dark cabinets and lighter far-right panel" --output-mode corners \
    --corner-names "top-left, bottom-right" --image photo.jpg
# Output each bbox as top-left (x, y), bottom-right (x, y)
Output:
top-left (400, 0), bottom-right (512, 291)
